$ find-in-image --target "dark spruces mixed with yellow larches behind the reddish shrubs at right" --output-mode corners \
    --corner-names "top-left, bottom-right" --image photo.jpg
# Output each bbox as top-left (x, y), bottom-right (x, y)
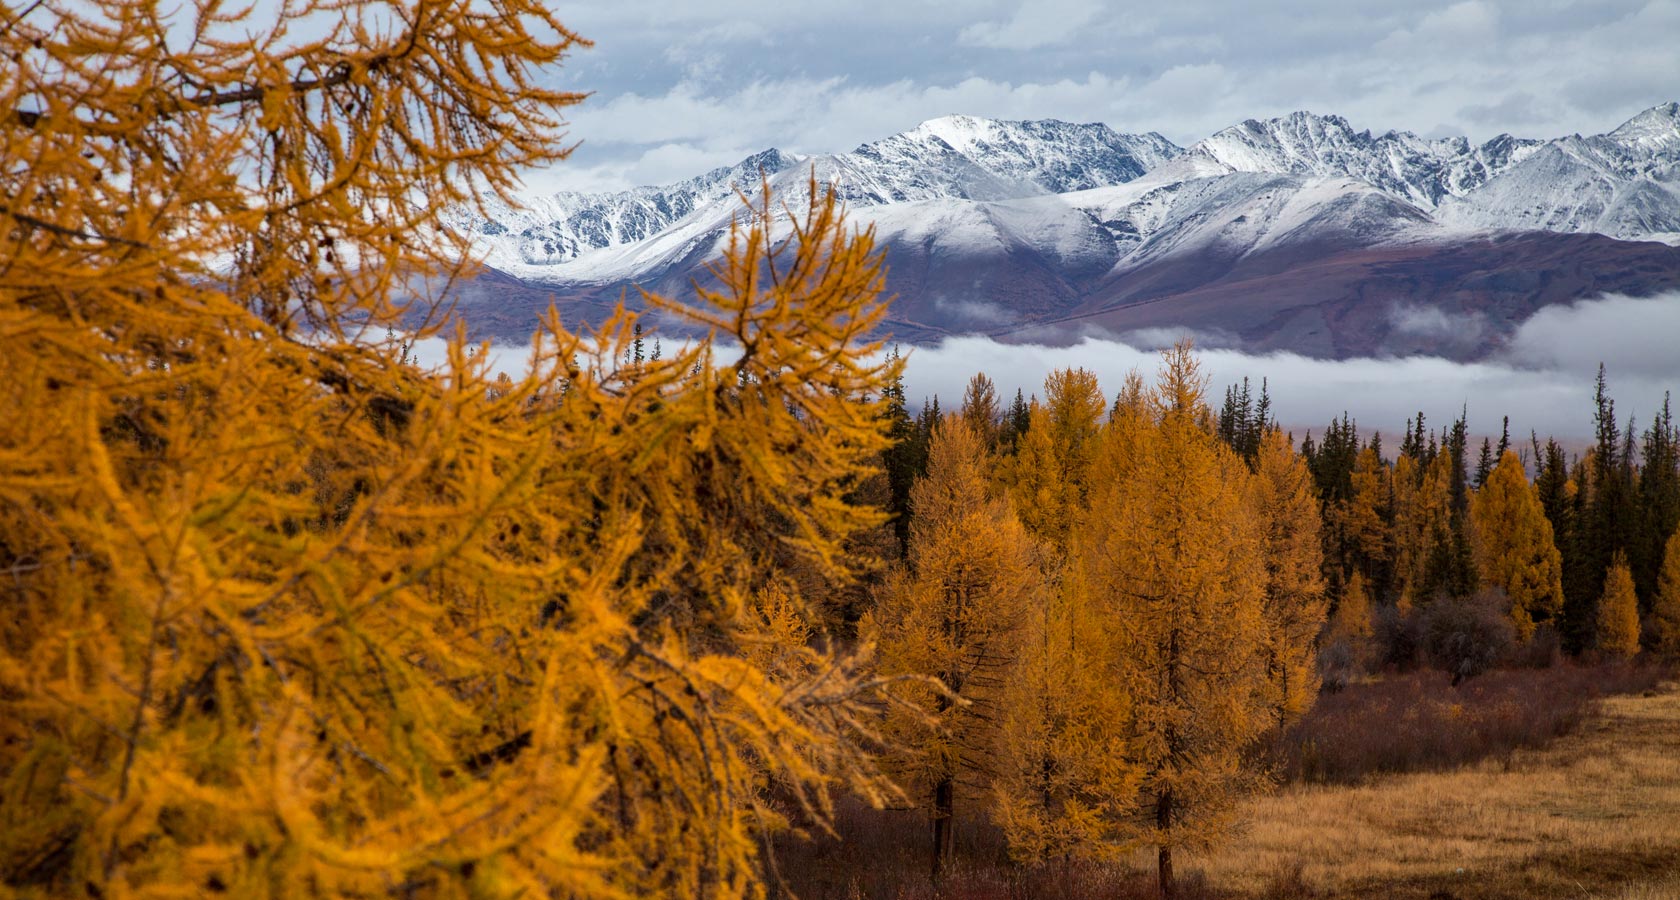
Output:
top-left (1276, 368), bottom-right (1680, 665)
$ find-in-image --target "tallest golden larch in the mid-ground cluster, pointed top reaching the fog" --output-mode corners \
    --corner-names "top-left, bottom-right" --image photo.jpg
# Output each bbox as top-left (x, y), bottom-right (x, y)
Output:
top-left (1074, 344), bottom-right (1273, 893)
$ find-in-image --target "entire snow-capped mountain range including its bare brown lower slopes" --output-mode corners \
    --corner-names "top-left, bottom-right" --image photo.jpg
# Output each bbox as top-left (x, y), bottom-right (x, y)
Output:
top-left (452, 104), bottom-right (1680, 356)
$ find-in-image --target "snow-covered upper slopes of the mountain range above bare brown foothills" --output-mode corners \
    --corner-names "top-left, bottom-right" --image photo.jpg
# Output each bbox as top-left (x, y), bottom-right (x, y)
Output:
top-left (449, 102), bottom-right (1680, 282)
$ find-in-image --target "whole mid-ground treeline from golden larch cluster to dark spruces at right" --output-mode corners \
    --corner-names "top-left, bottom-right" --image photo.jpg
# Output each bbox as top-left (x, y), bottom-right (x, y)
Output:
top-left (858, 359), bottom-right (1680, 892)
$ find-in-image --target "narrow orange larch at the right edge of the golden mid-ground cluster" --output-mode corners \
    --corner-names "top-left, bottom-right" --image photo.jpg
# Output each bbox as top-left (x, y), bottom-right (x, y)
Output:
top-left (1253, 428), bottom-right (1326, 725)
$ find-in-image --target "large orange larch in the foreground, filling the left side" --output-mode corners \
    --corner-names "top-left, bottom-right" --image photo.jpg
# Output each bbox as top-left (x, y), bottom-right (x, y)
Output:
top-left (0, 0), bottom-right (892, 897)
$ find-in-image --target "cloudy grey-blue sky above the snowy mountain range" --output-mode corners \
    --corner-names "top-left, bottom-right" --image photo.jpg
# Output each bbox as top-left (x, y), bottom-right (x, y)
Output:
top-left (526, 0), bottom-right (1680, 191)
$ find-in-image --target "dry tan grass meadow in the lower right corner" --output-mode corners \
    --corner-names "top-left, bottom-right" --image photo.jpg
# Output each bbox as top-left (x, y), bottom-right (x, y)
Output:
top-left (1201, 683), bottom-right (1680, 900)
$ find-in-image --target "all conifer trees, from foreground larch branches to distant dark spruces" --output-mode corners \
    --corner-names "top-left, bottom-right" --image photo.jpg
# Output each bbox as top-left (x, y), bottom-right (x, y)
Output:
top-left (0, 0), bottom-right (1680, 898)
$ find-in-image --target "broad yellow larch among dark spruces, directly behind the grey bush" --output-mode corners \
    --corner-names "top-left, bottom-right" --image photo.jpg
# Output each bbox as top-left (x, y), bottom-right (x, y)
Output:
top-left (1470, 450), bottom-right (1564, 641)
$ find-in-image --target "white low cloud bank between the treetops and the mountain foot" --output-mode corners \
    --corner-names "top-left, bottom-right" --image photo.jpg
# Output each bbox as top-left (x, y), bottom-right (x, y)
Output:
top-left (415, 294), bottom-right (1680, 443)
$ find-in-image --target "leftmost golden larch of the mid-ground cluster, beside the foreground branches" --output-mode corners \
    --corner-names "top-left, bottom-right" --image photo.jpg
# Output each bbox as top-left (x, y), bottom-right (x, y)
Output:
top-left (864, 416), bottom-right (1043, 871)
